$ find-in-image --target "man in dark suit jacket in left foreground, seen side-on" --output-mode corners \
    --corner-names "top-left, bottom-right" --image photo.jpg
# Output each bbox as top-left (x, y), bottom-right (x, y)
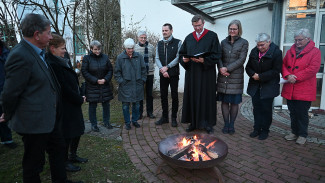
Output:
top-left (2, 13), bottom-right (78, 183)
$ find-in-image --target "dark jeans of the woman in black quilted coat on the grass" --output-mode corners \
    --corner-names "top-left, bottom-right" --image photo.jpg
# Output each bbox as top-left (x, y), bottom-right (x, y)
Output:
top-left (89, 101), bottom-right (110, 126)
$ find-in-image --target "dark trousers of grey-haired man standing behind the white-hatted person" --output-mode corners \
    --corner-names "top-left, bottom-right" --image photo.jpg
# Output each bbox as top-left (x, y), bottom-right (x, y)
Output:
top-left (140, 75), bottom-right (154, 115)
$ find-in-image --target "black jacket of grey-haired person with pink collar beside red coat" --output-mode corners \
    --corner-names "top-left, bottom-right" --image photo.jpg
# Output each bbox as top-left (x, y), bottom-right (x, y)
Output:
top-left (246, 43), bottom-right (282, 99)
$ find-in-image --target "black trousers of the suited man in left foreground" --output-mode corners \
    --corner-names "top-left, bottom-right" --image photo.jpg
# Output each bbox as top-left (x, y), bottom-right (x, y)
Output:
top-left (20, 128), bottom-right (67, 183)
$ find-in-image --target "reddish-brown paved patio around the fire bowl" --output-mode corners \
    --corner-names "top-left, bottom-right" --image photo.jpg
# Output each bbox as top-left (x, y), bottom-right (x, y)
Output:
top-left (121, 96), bottom-right (325, 183)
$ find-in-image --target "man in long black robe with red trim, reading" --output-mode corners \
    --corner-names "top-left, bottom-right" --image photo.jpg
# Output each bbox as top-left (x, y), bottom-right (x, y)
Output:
top-left (179, 15), bottom-right (221, 134)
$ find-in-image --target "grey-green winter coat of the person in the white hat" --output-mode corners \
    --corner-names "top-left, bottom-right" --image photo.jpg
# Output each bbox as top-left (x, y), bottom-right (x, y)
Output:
top-left (114, 51), bottom-right (147, 102)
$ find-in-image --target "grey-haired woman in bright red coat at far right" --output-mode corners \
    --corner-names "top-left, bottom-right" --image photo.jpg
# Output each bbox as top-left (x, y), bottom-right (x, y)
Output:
top-left (281, 29), bottom-right (321, 144)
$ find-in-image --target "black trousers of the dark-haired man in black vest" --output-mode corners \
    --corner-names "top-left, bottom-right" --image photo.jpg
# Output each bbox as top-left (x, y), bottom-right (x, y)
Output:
top-left (160, 75), bottom-right (179, 119)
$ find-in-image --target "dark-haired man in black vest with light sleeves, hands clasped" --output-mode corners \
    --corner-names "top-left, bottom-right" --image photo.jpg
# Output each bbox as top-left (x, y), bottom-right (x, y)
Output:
top-left (155, 23), bottom-right (182, 127)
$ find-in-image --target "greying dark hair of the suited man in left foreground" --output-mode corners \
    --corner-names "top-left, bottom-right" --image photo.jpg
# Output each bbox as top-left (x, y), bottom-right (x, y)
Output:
top-left (20, 13), bottom-right (51, 38)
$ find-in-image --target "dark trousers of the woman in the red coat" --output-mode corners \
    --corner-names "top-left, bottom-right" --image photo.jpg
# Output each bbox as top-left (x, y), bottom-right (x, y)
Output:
top-left (287, 100), bottom-right (311, 137)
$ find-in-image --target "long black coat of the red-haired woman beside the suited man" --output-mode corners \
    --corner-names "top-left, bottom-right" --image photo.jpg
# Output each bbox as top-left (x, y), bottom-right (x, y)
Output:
top-left (47, 53), bottom-right (85, 138)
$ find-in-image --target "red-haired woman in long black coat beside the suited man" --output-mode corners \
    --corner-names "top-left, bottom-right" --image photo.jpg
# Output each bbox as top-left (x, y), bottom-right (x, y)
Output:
top-left (46, 34), bottom-right (88, 171)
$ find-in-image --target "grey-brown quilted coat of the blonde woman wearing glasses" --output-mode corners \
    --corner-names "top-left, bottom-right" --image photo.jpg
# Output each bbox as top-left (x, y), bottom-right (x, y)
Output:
top-left (217, 36), bottom-right (248, 94)
